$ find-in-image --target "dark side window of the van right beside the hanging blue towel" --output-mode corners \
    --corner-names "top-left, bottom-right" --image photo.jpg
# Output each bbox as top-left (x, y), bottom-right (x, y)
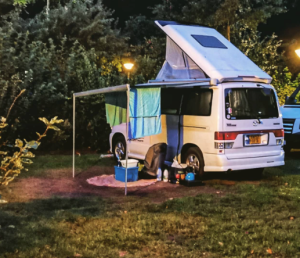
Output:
top-left (161, 88), bottom-right (182, 115)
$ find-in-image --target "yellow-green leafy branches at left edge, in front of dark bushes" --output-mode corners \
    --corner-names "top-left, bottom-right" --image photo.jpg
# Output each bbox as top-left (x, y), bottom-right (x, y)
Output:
top-left (0, 90), bottom-right (63, 186)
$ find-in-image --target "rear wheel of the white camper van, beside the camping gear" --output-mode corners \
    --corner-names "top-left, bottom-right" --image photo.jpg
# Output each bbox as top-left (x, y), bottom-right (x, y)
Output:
top-left (182, 147), bottom-right (204, 178)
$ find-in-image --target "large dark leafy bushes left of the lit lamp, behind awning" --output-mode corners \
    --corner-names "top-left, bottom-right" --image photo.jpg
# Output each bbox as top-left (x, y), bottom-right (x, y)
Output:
top-left (0, 1), bottom-right (127, 151)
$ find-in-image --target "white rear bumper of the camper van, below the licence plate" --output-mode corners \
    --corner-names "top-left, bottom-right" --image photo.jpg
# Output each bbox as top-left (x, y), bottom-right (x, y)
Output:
top-left (204, 151), bottom-right (284, 172)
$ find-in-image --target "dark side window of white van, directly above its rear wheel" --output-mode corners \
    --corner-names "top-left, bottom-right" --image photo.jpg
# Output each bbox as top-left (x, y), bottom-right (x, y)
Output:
top-left (181, 89), bottom-right (213, 116)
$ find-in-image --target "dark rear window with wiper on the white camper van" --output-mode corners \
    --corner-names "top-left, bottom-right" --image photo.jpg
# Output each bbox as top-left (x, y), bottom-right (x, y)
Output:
top-left (225, 88), bottom-right (279, 120)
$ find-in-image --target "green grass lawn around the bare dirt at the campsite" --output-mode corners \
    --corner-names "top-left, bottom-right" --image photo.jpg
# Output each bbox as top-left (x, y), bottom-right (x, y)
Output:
top-left (0, 153), bottom-right (300, 258)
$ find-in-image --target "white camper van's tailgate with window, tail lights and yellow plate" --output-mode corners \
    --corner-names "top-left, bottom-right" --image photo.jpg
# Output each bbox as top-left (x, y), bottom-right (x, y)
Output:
top-left (220, 84), bottom-right (283, 159)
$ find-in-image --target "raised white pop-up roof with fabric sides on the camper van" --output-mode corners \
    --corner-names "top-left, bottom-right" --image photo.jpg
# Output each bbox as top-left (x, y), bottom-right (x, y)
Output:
top-left (148, 21), bottom-right (272, 85)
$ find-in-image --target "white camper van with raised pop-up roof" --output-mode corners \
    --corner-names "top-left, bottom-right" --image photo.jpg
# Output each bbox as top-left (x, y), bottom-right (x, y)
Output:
top-left (110, 21), bottom-right (284, 175)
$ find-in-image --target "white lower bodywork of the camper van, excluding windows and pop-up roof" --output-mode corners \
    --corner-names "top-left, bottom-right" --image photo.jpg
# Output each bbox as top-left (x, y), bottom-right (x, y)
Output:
top-left (110, 82), bottom-right (284, 172)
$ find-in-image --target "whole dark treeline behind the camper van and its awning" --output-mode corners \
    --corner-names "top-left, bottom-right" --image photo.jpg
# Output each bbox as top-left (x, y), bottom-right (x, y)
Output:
top-left (0, 0), bottom-right (299, 151)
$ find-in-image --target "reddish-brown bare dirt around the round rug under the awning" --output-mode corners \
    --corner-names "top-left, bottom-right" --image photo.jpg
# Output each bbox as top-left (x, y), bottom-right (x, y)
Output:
top-left (2, 166), bottom-right (259, 203)
